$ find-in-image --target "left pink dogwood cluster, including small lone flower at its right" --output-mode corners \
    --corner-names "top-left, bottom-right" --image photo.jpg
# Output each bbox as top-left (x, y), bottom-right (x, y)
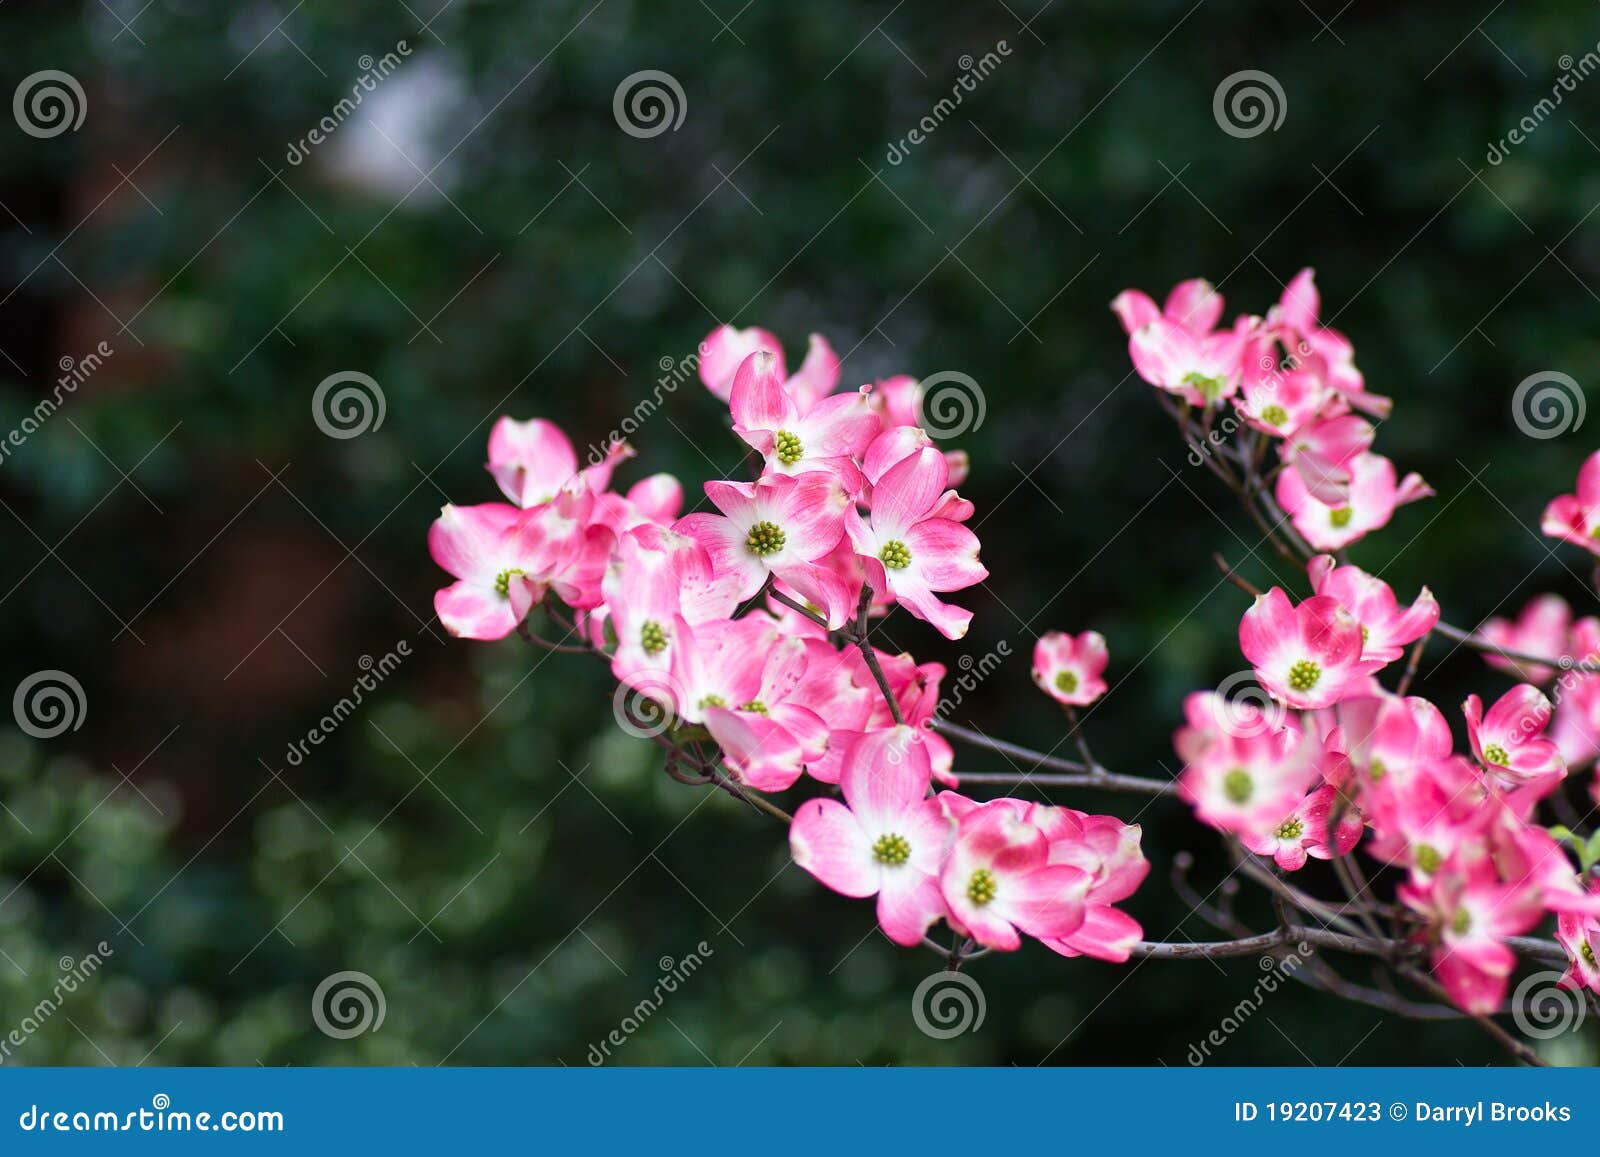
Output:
top-left (429, 326), bottom-right (1147, 960)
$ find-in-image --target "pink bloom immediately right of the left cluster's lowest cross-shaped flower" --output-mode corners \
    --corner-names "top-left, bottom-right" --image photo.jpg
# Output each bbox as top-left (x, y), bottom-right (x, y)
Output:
top-left (939, 792), bottom-right (1091, 952)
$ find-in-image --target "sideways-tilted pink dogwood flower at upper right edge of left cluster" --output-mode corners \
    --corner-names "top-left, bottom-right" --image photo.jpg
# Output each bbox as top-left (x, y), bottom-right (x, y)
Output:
top-left (845, 446), bottom-right (989, 639)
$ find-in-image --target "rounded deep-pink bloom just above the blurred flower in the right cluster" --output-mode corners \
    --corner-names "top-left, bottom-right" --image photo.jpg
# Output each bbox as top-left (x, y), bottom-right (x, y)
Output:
top-left (1238, 587), bottom-right (1384, 711)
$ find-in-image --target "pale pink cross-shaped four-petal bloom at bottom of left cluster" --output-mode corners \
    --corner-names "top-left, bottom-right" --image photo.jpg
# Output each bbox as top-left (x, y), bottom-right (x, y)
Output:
top-left (789, 728), bottom-right (954, 947)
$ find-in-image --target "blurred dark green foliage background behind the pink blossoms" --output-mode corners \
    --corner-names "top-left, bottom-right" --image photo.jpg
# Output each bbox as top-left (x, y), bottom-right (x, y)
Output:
top-left (0, 0), bottom-right (1600, 1066)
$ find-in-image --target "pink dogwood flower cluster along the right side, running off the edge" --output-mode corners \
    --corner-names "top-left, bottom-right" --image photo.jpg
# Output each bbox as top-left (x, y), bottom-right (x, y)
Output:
top-left (1112, 270), bottom-right (1600, 1013)
